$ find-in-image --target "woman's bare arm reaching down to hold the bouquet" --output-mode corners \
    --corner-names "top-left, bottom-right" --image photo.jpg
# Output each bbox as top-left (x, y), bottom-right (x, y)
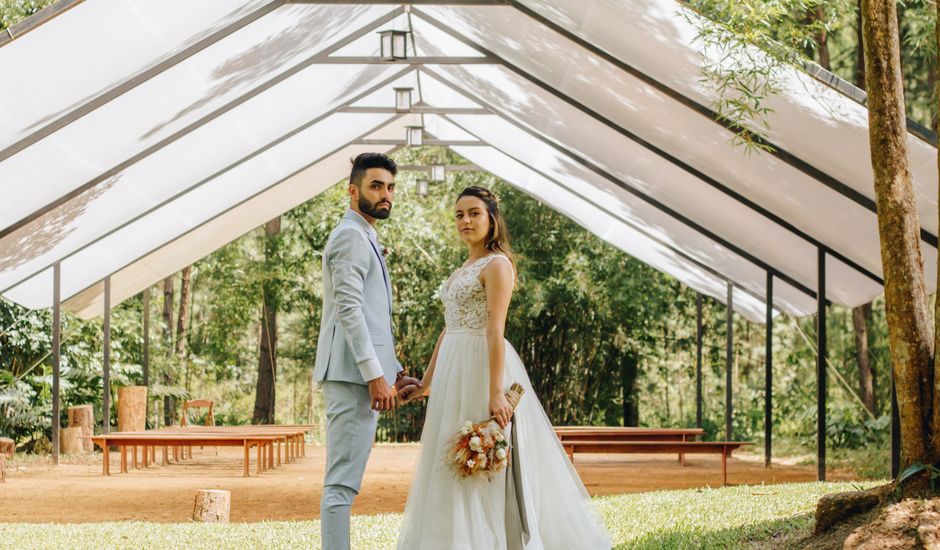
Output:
top-left (480, 257), bottom-right (513, 428)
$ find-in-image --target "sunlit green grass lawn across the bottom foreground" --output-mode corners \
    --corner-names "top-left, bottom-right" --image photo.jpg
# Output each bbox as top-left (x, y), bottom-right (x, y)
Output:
top-left (0, 482), bottom-right (878, 550)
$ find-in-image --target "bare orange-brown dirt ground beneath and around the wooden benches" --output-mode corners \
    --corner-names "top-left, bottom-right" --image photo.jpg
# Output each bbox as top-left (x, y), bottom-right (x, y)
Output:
top-left (0, 445), bottom-right (851, 523)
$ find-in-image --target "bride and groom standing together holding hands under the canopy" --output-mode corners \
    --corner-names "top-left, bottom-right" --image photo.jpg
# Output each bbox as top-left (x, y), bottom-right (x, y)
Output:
top-left (314, 153), bottom-right (611, 550)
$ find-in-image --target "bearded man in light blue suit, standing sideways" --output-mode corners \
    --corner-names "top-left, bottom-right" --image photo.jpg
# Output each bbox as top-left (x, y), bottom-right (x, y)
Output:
top-left (314, 153), bottom-right (420, 550)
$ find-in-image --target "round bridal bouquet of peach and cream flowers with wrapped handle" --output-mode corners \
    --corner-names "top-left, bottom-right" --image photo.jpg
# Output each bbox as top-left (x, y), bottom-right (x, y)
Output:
top-left (446, 383), bottom-right (525, 481)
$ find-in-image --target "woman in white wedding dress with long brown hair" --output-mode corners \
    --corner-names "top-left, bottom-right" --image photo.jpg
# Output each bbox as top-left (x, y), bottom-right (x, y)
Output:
top-left (398, 187), bottom-right (611, 550)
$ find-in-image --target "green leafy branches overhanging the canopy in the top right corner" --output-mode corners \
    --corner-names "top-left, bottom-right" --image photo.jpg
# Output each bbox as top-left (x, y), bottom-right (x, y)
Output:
top-left (682, 0), bottom-right (937, 137)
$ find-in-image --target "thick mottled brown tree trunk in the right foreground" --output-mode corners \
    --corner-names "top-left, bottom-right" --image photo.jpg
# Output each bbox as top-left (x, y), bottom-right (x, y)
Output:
top-left (862, 0), bottom-right (934, 495)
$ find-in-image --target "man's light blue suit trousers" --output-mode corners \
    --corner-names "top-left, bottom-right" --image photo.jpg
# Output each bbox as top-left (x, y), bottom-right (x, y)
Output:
top-left (320, 380), bottom-right (379, 550)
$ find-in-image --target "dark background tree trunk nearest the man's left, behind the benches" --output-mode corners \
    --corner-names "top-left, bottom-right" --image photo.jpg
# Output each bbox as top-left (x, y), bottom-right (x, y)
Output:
top-left (252, 217), bottom-right (281, 424)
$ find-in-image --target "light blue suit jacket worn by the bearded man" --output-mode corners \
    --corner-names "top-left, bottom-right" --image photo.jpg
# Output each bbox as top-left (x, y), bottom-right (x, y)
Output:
top-left (314, 210), bottom-right (402, 384)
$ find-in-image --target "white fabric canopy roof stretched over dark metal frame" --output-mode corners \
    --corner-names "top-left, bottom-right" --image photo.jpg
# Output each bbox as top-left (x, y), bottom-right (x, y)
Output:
top-left (0, 0), bottom-right (938, 322)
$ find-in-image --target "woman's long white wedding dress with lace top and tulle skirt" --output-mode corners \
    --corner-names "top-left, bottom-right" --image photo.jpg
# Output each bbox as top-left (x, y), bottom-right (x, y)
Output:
top-left (398, 254), bottom-right (611, 550)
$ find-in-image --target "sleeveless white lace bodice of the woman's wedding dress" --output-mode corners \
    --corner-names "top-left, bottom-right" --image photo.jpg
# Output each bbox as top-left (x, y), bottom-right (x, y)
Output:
top-left (441, 254), bottom-right (508, 331)
